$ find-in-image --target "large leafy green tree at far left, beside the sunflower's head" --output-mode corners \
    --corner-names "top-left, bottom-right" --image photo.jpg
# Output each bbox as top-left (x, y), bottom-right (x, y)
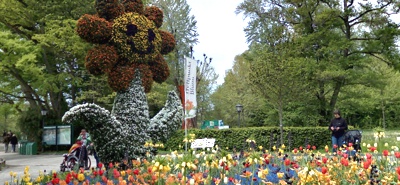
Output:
top-left (0, 0), bottom-right (94, 141)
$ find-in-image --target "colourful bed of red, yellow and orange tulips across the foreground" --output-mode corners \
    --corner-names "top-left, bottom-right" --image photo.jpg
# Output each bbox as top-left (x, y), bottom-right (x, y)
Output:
top-left (5, 141), bottom-right (400, 185)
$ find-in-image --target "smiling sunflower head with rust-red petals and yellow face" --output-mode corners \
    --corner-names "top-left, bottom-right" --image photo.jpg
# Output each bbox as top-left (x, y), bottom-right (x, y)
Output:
top-left (77, 0), bottom-right (175, 92)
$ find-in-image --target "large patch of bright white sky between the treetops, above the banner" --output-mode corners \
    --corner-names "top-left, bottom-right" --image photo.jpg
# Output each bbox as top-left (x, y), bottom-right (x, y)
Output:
top-left (187, 0), bottom-right (248, 84)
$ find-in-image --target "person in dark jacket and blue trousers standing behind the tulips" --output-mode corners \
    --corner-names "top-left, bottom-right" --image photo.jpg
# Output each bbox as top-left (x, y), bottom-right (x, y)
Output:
top-left (329, 110), bottom-right (347, 152)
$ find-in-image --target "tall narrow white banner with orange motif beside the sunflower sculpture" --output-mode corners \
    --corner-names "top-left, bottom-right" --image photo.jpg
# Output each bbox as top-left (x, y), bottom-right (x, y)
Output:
top-left (184, 57), bottom-right (197, 119)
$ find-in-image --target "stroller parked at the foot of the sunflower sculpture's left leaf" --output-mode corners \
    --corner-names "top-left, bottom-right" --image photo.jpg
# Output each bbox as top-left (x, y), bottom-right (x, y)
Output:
top-left (60, 142), bottom-right (91, 172)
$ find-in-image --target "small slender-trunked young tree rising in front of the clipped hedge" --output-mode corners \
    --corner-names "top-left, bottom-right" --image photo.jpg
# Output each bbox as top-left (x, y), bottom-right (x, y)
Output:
top-left (247, 41), bottom-right (310, 143)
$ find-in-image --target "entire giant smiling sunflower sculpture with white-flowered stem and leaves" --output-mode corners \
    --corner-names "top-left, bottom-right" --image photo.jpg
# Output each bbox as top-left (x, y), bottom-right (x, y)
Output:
top-left (63, 0), bottom-right (183, 162)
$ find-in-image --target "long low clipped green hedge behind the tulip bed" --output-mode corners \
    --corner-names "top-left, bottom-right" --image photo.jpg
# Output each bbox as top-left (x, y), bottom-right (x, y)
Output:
top-left (165, 127), bottom-right (331, 150)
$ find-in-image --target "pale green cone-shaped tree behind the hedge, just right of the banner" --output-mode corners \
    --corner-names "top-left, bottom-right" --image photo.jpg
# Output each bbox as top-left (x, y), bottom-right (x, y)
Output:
top-left (211, 54), bottom-right (268, 127)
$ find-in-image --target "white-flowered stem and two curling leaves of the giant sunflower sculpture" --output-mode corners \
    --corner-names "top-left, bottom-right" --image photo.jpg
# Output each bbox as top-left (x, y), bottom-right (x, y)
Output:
top-left (62, 72), bottom-right (183, 162)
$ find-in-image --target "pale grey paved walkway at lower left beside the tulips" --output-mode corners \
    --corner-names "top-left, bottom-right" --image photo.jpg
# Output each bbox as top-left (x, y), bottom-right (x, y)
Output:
top-left (0, 144), bottom-right (95, 185)
